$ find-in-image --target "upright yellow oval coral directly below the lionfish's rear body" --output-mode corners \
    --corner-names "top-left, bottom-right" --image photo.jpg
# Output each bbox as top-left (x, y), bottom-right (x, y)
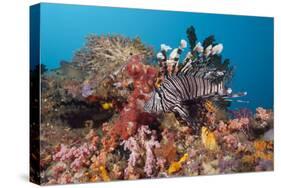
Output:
top-left (201, 127), bottom-right (218, 150)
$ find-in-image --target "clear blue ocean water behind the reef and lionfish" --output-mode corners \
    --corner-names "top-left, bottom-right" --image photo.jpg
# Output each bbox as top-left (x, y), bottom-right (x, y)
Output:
top-left (40, 3), bottom-right (274, 109)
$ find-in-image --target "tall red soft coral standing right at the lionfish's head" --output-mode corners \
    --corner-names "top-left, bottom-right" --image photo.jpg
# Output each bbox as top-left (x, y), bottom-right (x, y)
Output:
top-left (107, 55), bottom-right (157, 145)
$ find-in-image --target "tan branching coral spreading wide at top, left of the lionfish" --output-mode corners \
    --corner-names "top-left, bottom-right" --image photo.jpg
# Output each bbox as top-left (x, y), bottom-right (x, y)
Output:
top-left (73, 35), bottom-right (153, 95)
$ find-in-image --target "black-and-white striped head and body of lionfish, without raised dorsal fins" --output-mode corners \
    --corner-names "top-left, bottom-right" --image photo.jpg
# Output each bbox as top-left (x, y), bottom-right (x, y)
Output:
top-left (144, 74), bottom-right (226, 122)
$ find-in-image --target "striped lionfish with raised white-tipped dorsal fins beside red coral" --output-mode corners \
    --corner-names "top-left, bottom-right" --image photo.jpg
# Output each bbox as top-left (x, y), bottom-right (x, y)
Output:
top-left (144, 27), bottom-right (246, 128)
